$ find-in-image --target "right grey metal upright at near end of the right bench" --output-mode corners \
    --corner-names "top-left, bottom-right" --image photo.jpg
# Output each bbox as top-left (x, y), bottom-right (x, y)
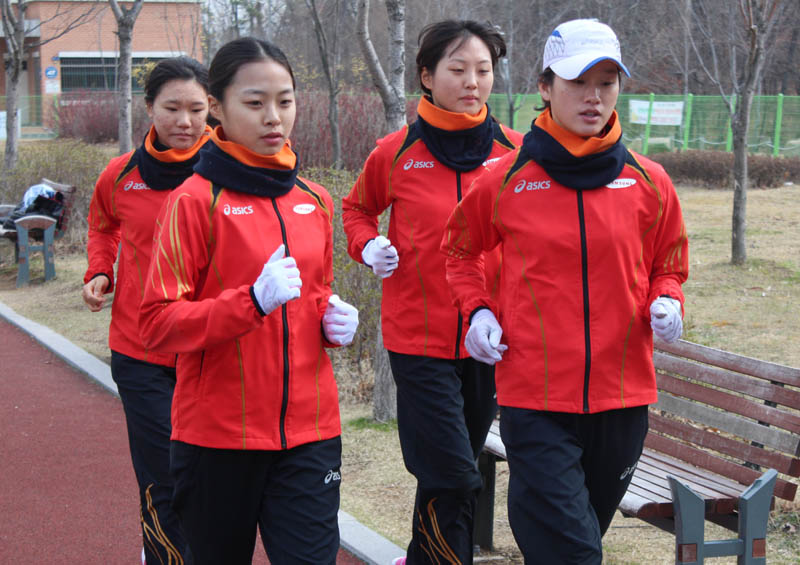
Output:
top-left (737, 469), bottom-right (778, 565)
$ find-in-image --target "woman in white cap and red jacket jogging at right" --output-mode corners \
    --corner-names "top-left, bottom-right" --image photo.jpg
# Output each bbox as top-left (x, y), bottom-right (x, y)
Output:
top-left (442, 20), bottom-right (688, 564)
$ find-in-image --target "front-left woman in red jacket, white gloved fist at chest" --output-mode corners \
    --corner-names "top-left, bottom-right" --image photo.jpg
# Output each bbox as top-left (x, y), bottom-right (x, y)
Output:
top-left (140, 38), bottom-right (358, 565)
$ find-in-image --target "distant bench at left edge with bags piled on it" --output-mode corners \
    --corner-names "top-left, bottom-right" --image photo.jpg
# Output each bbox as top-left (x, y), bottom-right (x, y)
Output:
top-left (0, 178), bottom-right (76, 287)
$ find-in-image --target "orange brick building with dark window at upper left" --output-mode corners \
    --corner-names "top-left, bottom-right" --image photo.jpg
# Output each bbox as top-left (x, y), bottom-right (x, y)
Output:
top-left (0, 0), bottom-right (202, 126)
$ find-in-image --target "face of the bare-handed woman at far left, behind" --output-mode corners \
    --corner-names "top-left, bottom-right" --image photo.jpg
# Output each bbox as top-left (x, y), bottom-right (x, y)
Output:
top-left (147, 79), bottom-right (208, 149)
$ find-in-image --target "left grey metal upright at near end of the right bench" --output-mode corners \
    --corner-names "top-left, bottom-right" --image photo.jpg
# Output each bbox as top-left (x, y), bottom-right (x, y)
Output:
top-left (667, 476), bottom-right (705, 564)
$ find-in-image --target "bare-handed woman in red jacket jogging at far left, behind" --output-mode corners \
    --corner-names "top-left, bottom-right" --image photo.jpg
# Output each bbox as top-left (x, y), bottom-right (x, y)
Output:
top-left (82, 57), bottom-right (210, 563)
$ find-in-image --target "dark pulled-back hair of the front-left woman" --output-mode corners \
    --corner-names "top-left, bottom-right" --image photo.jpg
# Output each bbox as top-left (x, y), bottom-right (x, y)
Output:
top-left (208, 37), bottom-right (296, 101)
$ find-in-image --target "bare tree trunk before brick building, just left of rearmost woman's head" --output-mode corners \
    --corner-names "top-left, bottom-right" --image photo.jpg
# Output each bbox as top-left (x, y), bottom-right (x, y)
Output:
top-left (108, 0), bottom-right (143, 153)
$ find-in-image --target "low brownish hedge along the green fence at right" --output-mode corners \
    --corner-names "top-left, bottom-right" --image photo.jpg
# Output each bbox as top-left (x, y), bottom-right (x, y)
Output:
top-left (650, 151), bottom-right (800, 188)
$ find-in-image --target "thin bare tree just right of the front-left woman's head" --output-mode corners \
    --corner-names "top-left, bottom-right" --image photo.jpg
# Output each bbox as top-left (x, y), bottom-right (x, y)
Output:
top-left (306, 0), bottom-right (342, 169)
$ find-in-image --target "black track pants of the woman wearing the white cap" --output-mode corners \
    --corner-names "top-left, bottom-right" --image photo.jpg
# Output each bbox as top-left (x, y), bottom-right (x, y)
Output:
top-left (500, 406), bottom-right (647, 565)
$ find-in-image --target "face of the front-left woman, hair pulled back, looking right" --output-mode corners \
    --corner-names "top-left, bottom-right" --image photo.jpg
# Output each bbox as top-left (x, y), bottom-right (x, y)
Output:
top-left (208, 59), bottom-right (297, 155)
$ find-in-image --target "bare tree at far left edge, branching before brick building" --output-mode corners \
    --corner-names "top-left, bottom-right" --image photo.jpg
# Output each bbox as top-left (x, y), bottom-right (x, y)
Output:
top-left (0, 0), bottom-right (98, 171)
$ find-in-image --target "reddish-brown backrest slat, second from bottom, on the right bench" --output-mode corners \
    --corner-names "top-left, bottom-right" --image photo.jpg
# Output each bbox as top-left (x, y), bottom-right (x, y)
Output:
top-left (649, 411), bottom-right (800, 477)
